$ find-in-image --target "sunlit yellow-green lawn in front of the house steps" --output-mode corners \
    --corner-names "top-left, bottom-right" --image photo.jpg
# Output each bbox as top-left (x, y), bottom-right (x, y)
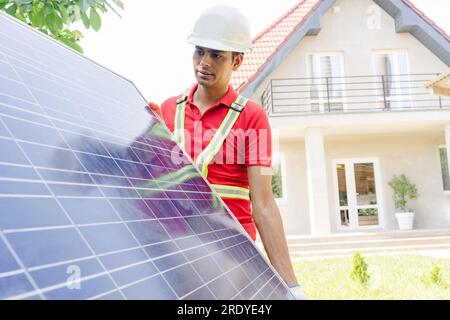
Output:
top-left (294, 255), bottom-right (450, 300)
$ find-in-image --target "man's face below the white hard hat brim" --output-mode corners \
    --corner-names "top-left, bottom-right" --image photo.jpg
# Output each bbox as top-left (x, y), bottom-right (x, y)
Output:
top-left (193, 46), bottom-right (242, 88)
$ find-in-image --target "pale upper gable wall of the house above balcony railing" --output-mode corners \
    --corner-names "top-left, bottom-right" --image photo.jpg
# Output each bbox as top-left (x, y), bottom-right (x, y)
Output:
top-left (252, 0), bottom-right (447, 101)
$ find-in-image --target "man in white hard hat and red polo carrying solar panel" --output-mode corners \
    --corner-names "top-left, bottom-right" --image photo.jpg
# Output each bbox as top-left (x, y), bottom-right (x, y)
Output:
top-left (150, 6), bottom-right (305, 299)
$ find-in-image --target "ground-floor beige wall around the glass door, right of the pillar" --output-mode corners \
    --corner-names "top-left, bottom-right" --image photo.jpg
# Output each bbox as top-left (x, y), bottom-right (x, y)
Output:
top-left (326, 132), bottom-right (450, 231)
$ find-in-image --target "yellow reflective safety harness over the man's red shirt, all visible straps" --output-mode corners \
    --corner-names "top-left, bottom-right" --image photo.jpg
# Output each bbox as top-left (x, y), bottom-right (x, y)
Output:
top-left (174, 91), bottom-right (250, 200)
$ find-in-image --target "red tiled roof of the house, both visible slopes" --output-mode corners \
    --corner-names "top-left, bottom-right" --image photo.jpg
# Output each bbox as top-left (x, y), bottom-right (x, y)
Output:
top-left (231, 0), bottom-right (450, 91)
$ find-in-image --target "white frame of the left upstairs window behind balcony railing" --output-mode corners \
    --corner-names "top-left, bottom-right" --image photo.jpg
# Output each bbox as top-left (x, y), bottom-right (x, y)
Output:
top-left (305, 51), bottom-right (347, 112)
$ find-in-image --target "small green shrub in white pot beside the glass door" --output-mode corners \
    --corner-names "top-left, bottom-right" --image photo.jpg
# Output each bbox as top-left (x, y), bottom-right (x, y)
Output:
top-left (389, 174), bottom-right (417, 230)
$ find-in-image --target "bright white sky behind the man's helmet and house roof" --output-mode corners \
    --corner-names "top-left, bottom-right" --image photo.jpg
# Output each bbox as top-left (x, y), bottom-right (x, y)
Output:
top-left (78, 0), bottom-right (450, 103)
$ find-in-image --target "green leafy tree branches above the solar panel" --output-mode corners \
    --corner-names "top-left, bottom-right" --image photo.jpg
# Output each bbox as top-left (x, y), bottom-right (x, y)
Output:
top-left (0, 0), bottom-right (124, 52)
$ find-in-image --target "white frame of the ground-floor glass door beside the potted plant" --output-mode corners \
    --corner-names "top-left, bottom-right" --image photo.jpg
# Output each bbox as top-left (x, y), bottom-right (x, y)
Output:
top-left (332, 157), bottom-right (386, 231)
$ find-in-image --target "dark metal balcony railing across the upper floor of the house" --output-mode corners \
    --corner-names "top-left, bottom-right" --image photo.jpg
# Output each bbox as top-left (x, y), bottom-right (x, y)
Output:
top-left (261, 73), bottom-right (450, 115)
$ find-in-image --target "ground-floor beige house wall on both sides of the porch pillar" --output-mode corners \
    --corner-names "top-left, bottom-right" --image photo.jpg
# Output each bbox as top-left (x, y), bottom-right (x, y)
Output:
top-left (279, 132), bottom-right (450, 235)
